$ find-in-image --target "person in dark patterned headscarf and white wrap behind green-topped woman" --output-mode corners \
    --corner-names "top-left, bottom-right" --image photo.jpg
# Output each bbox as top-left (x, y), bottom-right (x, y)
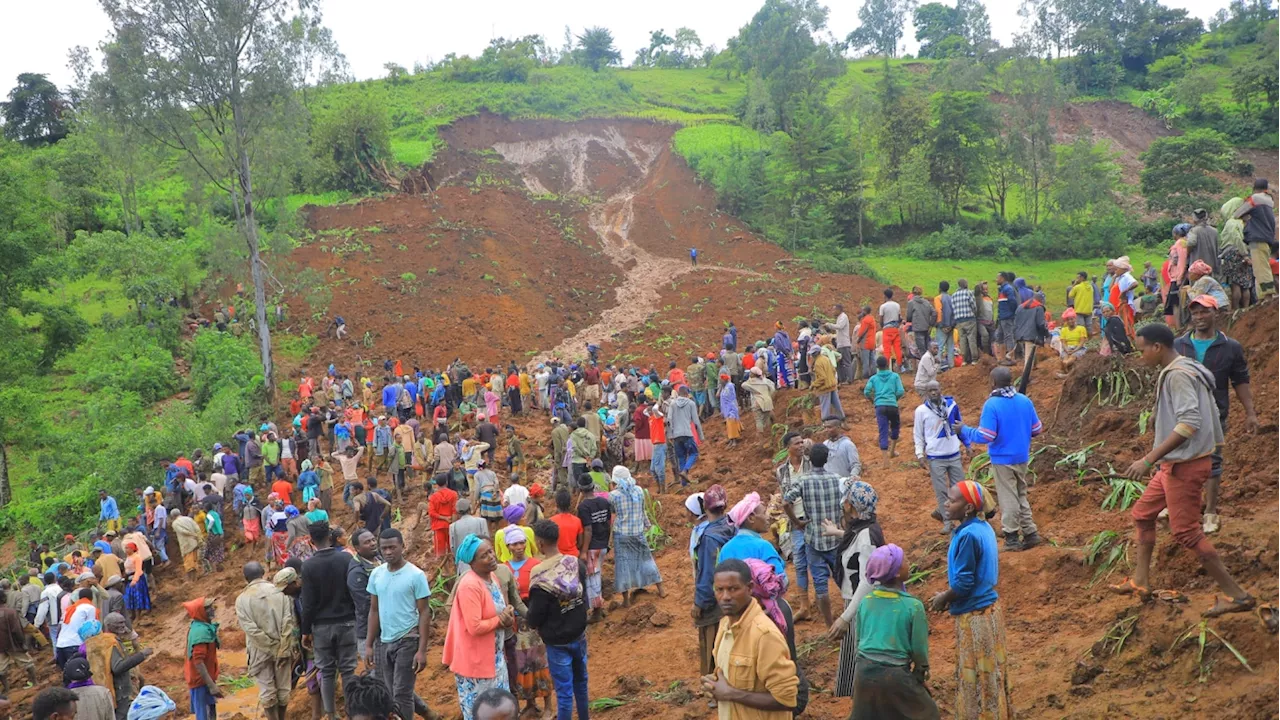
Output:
top-left (822, 480), bottom-right (884, 697)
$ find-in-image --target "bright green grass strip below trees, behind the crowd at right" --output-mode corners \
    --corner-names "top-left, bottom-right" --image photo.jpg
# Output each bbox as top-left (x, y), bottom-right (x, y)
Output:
top-left (864, 247), bottom-right (1165, 310)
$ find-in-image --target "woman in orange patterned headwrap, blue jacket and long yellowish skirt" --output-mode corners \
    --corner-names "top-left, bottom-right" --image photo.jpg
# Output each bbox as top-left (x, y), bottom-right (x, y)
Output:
top-left (929, 480), bottom-right (1014, 720)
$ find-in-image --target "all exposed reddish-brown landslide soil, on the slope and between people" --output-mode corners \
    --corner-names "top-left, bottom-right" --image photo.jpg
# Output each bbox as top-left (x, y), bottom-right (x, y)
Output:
top-left (20, 117), bottom-right (1280, 720)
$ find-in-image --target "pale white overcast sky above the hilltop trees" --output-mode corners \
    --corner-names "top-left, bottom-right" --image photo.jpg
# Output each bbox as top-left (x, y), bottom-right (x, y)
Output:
top-left (0, 0), bottom-right (1228, 95)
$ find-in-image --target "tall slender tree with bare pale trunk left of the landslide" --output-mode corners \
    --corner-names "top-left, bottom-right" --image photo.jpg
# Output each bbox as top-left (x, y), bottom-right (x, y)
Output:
top-left (95, 0), bottom-right (340, 395)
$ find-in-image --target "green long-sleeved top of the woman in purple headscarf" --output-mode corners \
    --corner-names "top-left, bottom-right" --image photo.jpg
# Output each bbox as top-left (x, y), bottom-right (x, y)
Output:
top-left (855, 584), bottom-right (929, 667)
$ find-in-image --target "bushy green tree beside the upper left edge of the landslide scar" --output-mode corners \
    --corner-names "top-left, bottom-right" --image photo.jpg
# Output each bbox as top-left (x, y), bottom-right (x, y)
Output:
top-left (311, 94), bottom-right (392, 192)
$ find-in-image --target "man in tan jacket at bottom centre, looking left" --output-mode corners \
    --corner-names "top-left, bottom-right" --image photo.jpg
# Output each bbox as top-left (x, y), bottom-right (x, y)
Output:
top-left (703, 560), bottom-right (800, 720)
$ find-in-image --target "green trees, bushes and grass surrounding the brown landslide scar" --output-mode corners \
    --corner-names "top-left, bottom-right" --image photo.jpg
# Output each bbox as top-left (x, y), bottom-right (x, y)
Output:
top-left (0, 0), bottom-right (1280, 530)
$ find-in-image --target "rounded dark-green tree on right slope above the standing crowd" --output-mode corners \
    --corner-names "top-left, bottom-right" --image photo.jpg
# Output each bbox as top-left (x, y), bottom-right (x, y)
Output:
top-left (1138, 129), bottom-right (1235, 214)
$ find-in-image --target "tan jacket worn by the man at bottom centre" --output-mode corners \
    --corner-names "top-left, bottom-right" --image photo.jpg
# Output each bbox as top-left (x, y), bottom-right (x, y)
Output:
top-left (716, 598), bottom-right (800, 720)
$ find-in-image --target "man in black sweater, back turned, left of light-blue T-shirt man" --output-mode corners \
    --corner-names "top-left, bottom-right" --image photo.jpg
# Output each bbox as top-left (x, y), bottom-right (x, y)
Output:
top-left (300, 520), bottom-right (357, 720)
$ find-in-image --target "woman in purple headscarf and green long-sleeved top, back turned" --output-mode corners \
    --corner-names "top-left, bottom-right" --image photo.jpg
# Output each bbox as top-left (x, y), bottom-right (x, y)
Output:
top-left (849, 544), bottom-right (938, 720)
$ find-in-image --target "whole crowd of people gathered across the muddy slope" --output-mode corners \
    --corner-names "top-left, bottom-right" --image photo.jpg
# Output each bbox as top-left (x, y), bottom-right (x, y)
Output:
top-left (0, 181), bottom-right (1275, 720)
